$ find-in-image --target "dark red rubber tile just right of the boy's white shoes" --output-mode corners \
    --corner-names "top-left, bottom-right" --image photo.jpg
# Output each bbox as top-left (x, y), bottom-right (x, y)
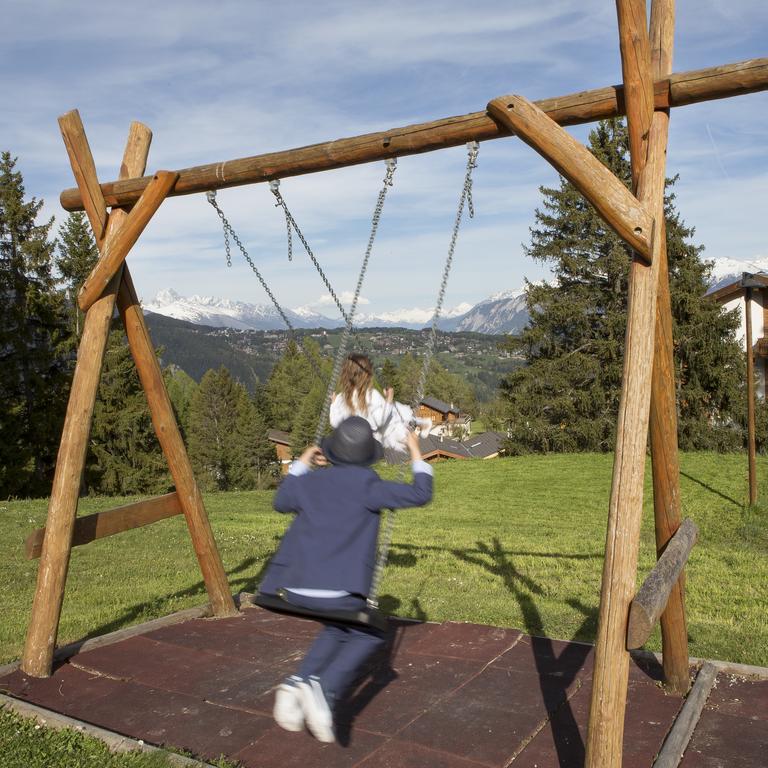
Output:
top-left (339, 654), bottom-right (483, 735)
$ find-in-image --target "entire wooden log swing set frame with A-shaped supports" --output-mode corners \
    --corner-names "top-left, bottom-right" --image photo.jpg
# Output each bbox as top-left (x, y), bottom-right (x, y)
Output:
top-left (21, 0), bottom-right (768, 768)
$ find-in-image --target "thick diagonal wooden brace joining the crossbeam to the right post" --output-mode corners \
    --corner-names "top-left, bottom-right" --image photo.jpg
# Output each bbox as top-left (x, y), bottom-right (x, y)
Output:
top-left (487, 96), bottom-right (653, 261)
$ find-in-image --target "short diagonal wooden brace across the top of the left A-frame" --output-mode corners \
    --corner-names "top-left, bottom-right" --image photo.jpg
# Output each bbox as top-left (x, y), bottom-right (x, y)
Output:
top-left (77, 171), bottom-right (179, 312)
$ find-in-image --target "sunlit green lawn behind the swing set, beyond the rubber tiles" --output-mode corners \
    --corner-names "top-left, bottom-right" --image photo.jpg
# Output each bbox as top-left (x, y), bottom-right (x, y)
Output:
top-left (0, 454), bottom-right (768, 666)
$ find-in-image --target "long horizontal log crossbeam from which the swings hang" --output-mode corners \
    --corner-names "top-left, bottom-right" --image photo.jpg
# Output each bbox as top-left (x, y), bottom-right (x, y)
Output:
top-left (60, 59), bottom-right (768, 211)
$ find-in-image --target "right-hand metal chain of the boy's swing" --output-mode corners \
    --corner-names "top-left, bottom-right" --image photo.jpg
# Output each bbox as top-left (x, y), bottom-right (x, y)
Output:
top-left (367, 141), bottom-right (480, 608)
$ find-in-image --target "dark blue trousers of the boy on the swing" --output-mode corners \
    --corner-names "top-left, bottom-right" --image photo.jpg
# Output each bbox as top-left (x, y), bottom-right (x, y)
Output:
top-left (282, 593), bottom-right (386, 701)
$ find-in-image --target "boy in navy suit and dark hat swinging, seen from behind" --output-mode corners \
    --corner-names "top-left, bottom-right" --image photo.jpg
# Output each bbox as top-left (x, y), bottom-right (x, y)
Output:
top-left (259, 416), bottom-right (432, 742)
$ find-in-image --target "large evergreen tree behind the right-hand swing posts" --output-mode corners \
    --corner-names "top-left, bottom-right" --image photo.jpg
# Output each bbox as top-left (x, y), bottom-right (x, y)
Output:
top-left (501, 120), bottom-right (743, 451)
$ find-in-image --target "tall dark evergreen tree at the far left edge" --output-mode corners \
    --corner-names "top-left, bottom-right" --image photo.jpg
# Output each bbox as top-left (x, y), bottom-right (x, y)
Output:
top-left (0, 152), bottom-right (66, 497)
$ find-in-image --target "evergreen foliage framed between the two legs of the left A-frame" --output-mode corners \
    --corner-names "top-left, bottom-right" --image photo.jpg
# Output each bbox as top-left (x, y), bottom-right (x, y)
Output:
top-left (85, 331), bottom-right (172, 496)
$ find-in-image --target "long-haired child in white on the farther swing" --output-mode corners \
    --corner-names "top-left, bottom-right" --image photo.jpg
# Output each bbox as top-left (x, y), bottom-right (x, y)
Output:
top-left (328, 353), bottom-right (432, 451)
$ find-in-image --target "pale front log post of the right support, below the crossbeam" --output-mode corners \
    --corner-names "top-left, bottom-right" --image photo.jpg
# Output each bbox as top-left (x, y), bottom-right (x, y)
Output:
top-left (585, 112), bottom-right (669, 768)
